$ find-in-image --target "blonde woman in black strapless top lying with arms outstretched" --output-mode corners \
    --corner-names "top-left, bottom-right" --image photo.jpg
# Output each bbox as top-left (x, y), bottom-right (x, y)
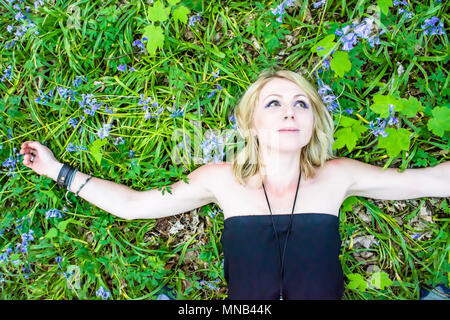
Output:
top-left (21, 70), bottom-right (450, 299)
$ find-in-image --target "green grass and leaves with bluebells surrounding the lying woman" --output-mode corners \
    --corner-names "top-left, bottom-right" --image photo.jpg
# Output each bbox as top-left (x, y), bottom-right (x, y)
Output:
top-left (0, 0), bottom-right (450, 300)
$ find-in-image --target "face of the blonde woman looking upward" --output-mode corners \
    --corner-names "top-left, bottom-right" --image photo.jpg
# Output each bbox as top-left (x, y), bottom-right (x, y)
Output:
top-left (252, 78), bottom-right (314, 151)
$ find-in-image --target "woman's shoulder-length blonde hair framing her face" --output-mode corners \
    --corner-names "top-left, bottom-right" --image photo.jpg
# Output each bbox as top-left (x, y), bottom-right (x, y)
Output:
top-left (232, 68), bottom-right (337, 185)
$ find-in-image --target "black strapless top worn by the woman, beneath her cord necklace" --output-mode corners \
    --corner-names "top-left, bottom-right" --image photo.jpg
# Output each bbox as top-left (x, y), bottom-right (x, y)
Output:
top-left (221, 213), bottom-right (344, 300)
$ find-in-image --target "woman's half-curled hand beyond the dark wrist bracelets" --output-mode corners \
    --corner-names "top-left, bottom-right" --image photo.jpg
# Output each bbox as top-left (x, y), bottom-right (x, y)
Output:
top-left (20, 141), bottom-right (62, 180)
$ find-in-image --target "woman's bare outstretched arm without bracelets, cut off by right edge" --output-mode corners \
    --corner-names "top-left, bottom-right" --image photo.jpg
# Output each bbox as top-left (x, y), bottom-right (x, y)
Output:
top-left (339, 158), bottom-right (450, 200)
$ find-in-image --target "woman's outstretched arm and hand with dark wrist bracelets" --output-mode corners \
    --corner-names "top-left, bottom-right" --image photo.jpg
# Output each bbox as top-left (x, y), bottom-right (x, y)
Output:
top-left (20, 141), bottom-right (216, 220)
